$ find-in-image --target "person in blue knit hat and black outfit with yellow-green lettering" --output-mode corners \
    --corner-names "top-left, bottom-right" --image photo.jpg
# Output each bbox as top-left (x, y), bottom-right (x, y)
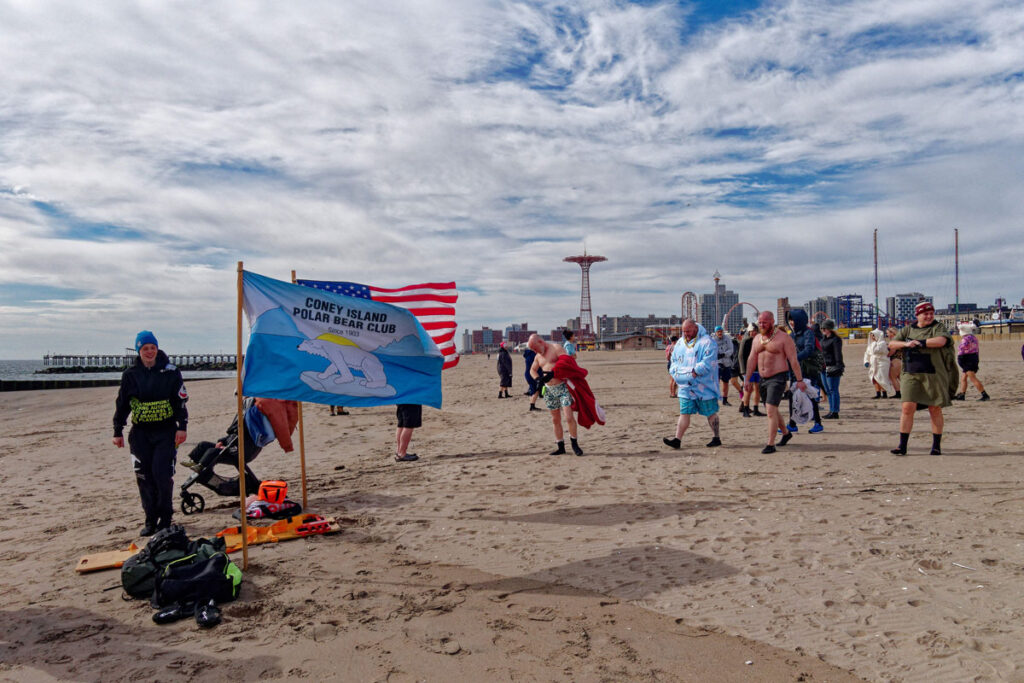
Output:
top-left (114, 330), bottom-right (188, 536)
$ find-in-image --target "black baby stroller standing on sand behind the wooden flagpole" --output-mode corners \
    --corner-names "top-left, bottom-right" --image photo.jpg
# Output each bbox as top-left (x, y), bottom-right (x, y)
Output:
top-left (181, 398), bottom-right (274, 515)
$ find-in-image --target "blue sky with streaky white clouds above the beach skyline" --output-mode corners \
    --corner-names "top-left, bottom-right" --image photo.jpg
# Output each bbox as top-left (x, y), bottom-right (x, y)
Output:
top-left (0, 0), bottom-right (1024, 358)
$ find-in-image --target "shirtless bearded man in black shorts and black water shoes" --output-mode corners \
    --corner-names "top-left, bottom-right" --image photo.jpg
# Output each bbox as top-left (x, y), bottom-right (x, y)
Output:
top-left (743, 310), bottom-right (807, 454)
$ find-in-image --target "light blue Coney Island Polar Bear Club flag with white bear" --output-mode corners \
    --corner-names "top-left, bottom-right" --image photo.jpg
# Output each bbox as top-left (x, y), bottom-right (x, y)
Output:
top-left (242, 271), bottom-right (444, 409)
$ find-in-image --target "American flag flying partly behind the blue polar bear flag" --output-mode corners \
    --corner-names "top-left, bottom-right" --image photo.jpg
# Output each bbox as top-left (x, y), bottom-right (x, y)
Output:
top-left (295, 280), bottom-right (459, 370)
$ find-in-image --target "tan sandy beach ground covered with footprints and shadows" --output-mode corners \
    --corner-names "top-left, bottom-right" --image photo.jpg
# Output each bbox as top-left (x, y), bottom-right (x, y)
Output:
top-left (0, 342), bottom-right (1024, 681)
